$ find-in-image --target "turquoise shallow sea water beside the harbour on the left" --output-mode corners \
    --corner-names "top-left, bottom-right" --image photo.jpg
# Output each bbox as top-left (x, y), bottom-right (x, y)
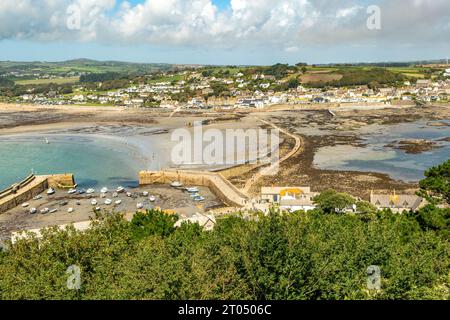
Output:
top-left (0, 135), bottom-right (155, 189)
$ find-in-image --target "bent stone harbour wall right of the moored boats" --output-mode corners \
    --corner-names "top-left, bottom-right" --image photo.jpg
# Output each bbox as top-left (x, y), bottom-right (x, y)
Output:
top-left (139, 170), bottom-right (248, 207)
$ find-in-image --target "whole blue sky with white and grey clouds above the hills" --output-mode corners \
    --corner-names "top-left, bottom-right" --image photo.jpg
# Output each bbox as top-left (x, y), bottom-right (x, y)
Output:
top-left (0, 0), bottom-right (450, 65)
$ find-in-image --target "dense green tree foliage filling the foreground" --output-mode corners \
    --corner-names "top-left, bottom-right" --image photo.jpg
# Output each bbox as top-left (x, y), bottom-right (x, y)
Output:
top-left (0, 162), bottom-right (450, 300)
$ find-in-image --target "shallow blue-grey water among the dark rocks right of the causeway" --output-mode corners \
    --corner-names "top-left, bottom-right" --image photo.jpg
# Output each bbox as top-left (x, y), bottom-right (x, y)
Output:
top-left (314, 121), bottom-right (450, 182)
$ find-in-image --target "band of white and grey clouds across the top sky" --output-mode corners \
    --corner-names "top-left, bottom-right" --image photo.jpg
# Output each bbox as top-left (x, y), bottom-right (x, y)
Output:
top-left (0, 0), bottom-right (450, 52)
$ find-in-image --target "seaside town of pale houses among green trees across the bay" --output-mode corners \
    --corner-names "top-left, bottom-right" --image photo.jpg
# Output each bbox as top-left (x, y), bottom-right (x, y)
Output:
top-left (0, 64), bottom-right (450, 110)
